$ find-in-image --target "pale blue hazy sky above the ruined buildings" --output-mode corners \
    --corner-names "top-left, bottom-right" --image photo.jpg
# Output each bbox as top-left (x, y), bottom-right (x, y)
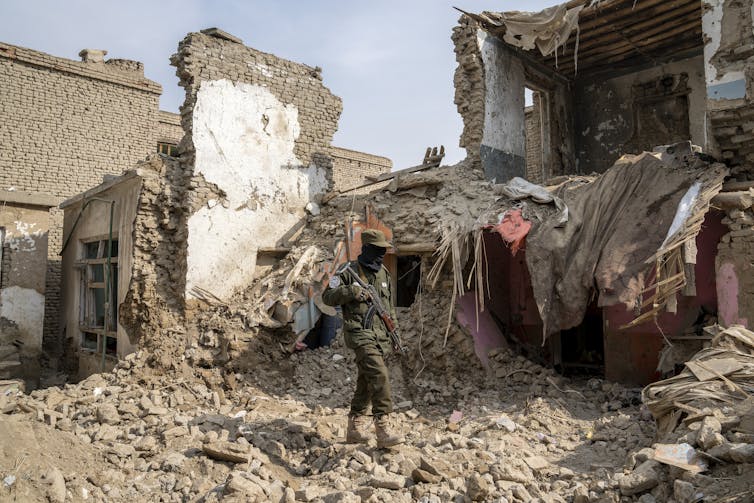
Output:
top-left (0, 0), bottom-right (559, 169)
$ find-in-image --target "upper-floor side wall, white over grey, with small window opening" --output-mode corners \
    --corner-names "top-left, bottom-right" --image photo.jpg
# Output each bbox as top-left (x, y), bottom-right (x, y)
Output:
top-left (452, 15), bottom-right (576, 183)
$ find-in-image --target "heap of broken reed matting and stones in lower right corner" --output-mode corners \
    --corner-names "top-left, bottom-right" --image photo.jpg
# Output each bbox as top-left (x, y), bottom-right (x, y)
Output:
top-left (621, 325), bottom-right (754, 503)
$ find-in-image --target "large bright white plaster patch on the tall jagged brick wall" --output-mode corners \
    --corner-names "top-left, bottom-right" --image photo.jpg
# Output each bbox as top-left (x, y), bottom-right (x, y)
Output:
top-left (186, 80), bottom-right (327, 298)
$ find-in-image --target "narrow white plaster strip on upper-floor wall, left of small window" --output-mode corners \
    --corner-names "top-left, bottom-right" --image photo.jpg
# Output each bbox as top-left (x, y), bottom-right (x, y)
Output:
top-left (477, 30), bottom-right (526, 158)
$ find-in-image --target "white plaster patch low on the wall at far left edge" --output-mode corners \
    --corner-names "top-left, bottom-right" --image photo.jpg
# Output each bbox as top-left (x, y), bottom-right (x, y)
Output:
top-left (0, 286), bottom-right (45, 353)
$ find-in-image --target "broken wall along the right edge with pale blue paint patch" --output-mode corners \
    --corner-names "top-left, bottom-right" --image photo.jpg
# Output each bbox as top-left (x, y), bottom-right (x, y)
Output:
top-left (702, 0), bottom-right (754, 328)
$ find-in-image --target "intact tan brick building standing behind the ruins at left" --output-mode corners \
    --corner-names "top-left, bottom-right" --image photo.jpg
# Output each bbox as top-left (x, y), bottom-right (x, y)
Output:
top-left (0, 35), bottom-right (392, 377)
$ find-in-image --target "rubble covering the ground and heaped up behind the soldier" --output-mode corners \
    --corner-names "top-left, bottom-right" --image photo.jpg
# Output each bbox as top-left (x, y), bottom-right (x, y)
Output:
top-left (0, 160), bottom-right (750, 503)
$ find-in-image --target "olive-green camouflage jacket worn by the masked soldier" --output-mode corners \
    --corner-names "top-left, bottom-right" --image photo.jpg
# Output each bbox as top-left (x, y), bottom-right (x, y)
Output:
top-left (322, 261), bottom-right (395, 354)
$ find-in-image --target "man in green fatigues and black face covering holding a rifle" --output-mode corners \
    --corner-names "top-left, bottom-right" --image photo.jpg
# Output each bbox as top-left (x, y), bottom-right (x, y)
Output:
top-left (322, 229), bottom-right (404, 448)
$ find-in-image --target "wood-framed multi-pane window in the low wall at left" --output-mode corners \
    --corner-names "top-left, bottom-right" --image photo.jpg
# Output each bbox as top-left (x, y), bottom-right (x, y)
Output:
top-left (77, 239), bottom-right (118, 356)
